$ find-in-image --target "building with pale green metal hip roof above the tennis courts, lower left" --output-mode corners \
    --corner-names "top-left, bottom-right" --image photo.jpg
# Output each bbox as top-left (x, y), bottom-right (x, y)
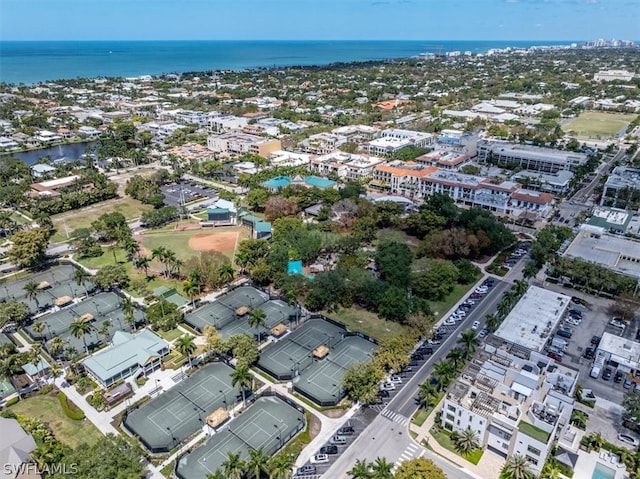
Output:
top-left (83, 329), bottom-right (169, 387)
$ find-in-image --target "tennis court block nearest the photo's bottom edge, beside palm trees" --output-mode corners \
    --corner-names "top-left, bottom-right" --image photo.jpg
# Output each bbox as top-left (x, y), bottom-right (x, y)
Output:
top-left (176, 396), bottom-right (305, 479)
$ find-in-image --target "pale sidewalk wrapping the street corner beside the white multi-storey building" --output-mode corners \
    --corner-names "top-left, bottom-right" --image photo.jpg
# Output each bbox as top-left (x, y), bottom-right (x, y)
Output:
top-left (409, 403), bottom-right (505, 479)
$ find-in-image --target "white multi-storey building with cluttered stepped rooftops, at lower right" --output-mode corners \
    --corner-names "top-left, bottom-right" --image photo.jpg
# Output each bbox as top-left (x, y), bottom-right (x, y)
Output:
top-left (442, 347), bottom-right (578, 475)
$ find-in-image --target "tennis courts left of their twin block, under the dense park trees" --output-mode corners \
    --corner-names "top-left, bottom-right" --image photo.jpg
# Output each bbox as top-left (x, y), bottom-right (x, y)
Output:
top-left (258, 319), bottom-right (346, 381)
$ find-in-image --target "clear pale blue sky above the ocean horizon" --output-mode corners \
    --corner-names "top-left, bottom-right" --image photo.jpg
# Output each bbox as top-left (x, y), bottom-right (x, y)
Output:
top-left (0, 0), bottom-right (640, 40)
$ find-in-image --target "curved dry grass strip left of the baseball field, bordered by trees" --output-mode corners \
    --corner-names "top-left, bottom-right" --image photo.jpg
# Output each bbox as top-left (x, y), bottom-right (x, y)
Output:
top-left (51, 196), bottom-right (151, 243)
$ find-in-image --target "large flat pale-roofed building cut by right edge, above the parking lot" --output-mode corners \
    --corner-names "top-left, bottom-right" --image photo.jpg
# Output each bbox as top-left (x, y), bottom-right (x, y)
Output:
top-left (564, 225), bottom-right (640, 278)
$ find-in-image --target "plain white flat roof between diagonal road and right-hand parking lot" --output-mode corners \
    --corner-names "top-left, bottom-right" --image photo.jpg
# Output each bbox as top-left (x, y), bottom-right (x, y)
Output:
top-left (495, 286), bottom-right (571, 352)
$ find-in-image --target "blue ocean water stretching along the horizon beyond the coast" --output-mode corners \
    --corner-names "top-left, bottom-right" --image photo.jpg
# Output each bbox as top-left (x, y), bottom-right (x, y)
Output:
top-left (0, 40), bottom-right (571, 84)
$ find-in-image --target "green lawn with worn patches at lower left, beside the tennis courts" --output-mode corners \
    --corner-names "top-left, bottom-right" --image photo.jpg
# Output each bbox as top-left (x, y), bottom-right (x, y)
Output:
top-left (10, 396), bottom-right (101, 448)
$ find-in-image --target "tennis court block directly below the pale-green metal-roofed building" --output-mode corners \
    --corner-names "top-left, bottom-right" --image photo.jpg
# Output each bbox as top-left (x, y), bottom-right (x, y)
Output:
top-left (123, 363), bottom-right (238, 454)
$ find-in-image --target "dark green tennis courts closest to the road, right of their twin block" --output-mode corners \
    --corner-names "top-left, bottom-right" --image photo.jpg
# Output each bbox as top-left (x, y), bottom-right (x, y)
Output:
top-left (293, 336), bottom-right (376, 406)
